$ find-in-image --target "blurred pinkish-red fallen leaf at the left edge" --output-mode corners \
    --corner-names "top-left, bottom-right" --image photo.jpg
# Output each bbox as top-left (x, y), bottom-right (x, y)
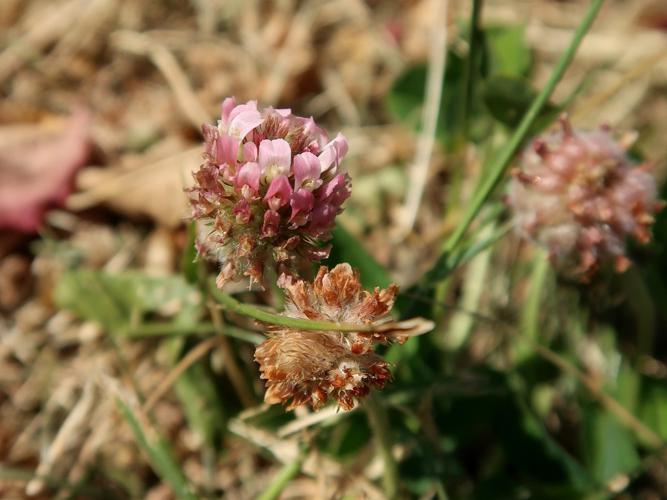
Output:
top-left (0, 111), bottom-right (89, 232)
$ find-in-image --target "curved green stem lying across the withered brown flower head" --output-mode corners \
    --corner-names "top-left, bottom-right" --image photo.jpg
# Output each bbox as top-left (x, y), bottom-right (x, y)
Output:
top-left (209, 281), bottom-right (377, 332)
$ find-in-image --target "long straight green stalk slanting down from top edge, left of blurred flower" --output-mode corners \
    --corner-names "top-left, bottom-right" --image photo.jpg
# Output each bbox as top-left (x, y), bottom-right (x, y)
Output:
top-left (444, 0), bottom-right (604, 252)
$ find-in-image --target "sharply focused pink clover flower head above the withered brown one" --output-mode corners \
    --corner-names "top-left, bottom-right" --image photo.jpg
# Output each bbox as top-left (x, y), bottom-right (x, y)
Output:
top-left (189, 97), bottom-right (351, 287)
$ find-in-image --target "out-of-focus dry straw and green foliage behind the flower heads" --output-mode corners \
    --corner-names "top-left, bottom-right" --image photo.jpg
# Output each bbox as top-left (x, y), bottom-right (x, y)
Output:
top-left (0, 0), bottom-right (667, 499)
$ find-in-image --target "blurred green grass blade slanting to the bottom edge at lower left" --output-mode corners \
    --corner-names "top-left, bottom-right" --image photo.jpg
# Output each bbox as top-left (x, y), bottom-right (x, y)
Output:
top-left (116, 399), bottom-right (197, 500)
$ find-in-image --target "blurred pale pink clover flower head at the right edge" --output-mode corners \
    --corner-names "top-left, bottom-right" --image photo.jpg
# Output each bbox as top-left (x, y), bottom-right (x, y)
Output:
top-left (507, 117), bottom-right (662, 280)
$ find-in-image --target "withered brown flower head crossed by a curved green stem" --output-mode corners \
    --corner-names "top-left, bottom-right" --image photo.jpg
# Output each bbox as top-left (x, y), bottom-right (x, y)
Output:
top-left (255, 264), bottom-right (432, 410)
